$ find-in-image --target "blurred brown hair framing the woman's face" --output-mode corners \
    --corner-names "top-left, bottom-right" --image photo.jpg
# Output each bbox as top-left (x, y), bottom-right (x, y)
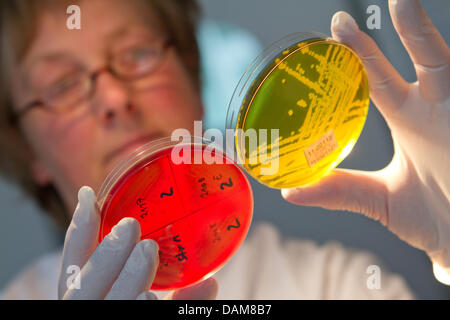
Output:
top-left (0, 0), bottom-right (200, 228)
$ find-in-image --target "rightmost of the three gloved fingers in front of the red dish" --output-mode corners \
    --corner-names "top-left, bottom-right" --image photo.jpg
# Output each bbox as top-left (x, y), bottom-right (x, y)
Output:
top-left (106, 239), bottom-right (159, 300)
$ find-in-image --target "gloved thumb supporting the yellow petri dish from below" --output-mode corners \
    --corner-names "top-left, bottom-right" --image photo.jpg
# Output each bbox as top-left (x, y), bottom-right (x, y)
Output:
top-left (281, 169), bottom-right (388, 226)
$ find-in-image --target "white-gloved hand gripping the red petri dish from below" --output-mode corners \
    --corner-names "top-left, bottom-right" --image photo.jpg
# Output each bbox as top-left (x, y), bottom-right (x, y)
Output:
top-left (58, 186), bottom-right (217, 300)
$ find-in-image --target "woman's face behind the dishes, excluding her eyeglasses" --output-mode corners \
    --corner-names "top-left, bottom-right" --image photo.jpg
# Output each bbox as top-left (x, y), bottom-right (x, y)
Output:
top-left (12, 0), bottom-right (202, 212)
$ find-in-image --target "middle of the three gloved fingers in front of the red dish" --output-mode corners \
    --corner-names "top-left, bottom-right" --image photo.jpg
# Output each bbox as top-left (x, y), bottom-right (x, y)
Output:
top-left (64, 218), bottom-right (142, 300)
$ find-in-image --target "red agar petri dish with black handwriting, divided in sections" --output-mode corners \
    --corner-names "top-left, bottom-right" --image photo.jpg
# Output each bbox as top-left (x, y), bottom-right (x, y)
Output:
top-left (97, 137), bottom-right (253, 290)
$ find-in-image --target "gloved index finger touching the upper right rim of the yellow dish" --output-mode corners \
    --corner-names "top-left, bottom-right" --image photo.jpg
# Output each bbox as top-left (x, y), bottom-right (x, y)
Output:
top-left (331, 11), bottom-right (408, 121)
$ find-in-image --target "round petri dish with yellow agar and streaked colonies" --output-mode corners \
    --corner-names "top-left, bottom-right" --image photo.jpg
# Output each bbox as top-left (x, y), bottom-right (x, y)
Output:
top-left (226, 31), bottom-right (369, 189)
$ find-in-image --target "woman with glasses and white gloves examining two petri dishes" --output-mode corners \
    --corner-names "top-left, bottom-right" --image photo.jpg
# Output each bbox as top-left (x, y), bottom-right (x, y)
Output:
top-left (1, 0), bottom-right (450, 299)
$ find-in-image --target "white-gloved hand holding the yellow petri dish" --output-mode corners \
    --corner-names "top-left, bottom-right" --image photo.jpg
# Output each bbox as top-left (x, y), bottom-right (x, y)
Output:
top-left (282, 0), bottom-right (450, 274)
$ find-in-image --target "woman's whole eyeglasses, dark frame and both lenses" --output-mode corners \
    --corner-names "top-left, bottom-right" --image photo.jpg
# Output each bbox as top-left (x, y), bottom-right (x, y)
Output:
top-left (11, 39), bottom-right (173, 123)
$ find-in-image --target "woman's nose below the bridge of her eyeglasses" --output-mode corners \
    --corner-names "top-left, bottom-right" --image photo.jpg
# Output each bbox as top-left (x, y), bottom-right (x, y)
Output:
top-left (92, 72), bottom-right (133, 124)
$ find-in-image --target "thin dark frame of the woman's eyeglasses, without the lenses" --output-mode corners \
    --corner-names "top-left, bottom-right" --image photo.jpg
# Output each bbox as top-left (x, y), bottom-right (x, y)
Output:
top-left (10, 38), bottom-right (175, 124)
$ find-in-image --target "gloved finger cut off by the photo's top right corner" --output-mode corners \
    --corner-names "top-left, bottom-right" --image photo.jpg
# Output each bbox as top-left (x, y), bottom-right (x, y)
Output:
top-left (389, 0), bottom-right (450, 102)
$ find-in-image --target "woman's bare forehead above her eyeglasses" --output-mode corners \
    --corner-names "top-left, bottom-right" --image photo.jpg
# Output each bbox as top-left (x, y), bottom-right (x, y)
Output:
top-left (21, 0), bottom-right (162, 68)
